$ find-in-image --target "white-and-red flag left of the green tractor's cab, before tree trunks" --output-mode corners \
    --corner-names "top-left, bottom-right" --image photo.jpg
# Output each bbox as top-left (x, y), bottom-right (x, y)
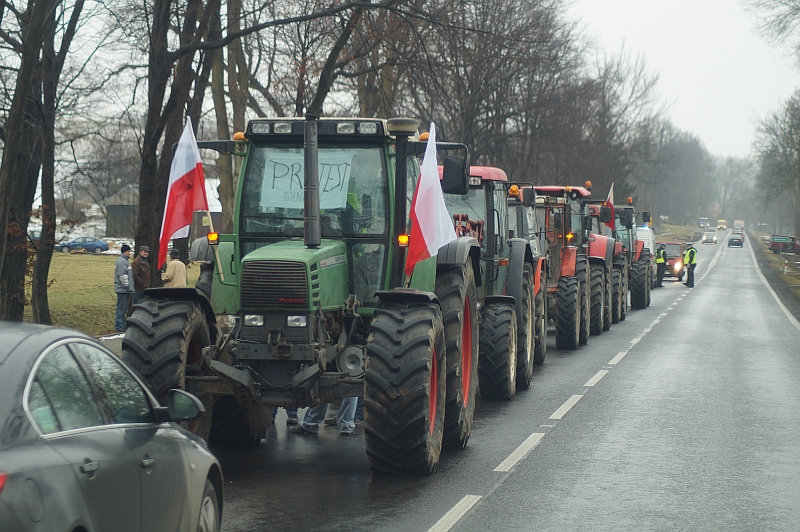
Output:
top-left (158, 118), bottom-right (208, 268)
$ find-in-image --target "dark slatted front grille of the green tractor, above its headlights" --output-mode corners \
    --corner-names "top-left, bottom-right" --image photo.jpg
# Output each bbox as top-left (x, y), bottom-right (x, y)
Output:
top-left (242, 260), bottom-right (308, 309)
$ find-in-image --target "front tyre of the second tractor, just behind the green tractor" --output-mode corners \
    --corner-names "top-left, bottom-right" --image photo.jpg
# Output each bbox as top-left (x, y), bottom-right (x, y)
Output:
top-left (478, 303), bottom-right (517, 400)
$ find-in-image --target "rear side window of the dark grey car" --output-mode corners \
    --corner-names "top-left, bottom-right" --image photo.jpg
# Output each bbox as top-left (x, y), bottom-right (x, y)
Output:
top-left (33, 345), bottom-right (105, 430)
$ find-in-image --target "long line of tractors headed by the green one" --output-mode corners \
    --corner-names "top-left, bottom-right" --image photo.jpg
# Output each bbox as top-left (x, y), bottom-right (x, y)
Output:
top-left (122, 116), bottom-right (654, 474)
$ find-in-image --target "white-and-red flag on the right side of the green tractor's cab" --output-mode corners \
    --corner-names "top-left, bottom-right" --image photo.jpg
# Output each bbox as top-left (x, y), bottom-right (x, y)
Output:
top-left (406, 123), bottom-right (457, 275)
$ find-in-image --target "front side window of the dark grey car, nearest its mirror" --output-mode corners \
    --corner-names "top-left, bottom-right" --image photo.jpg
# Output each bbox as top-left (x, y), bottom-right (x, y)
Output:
top-left (72, 343), bottom-right (155, 423)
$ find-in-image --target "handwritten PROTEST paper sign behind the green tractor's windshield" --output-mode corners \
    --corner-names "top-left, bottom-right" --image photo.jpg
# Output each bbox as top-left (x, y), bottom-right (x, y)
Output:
top-left (261, 150), bottom-right (353, 209)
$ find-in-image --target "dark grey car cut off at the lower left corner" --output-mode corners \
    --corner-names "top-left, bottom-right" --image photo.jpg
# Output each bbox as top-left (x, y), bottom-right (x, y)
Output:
top-left (0, 322), bottom-right (223, 532)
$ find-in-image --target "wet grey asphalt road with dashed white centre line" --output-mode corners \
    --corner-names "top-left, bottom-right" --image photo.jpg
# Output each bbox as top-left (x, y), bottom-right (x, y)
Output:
top-left (213, 238), bottom-right (800, 532)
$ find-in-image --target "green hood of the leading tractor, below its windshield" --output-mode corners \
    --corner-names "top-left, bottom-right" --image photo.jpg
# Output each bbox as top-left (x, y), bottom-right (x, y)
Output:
top-left (241, 239), bottom-right (349, 312)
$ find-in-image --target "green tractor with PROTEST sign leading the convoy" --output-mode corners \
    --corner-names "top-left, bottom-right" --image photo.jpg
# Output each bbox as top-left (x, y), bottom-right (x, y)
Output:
top-left (123, 116), bottom-right (482, 474)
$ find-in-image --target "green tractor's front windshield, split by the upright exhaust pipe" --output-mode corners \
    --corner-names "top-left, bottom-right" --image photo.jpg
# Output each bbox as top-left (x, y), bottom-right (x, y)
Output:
top-left (241, 145), bottom-right (389, 238)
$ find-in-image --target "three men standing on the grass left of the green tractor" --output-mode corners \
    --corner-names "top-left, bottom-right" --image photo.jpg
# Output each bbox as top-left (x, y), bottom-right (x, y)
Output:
top-left (114, 244), bottom-right (186, 332)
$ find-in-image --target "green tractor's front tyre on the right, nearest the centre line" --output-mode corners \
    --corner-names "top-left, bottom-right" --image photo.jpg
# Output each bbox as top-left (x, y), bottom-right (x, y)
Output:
top-left (364, 305), bottom-right (447, 475)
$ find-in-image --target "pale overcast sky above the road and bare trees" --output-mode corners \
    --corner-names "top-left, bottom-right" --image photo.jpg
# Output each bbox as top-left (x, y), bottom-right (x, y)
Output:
top-left (568, 0), bottom-right (800, 157)
